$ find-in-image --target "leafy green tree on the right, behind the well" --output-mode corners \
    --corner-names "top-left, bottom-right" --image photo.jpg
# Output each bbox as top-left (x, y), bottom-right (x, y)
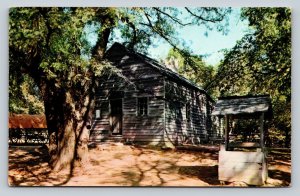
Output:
top-left (210, 8), bottom-right (291, 147)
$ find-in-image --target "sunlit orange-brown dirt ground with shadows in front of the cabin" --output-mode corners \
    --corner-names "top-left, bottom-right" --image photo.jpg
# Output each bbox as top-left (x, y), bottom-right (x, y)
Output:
top-left (8, 143), bottom-right (291, 187)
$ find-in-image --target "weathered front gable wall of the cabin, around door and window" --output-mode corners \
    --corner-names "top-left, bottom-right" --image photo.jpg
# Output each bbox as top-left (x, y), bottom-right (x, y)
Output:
top-left (90, 57), bottom-right (164, 144)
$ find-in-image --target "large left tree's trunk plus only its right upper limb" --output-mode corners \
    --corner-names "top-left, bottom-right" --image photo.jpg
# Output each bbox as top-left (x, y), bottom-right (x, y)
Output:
top-left (29, 7), bottom-right (113, 175)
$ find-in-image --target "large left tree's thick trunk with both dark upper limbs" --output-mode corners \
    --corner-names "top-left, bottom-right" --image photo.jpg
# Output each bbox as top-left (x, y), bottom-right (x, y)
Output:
top-left (10, 8), bottom-right (114, 176)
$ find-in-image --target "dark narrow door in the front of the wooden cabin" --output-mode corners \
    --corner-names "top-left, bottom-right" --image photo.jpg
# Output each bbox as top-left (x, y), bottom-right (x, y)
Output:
top-left (110, 99), bottom-right (122, 135)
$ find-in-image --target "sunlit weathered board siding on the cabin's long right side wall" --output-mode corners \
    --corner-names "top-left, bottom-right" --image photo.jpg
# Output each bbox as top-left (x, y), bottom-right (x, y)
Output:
top-left (165, 80), bottom-right (212, 145)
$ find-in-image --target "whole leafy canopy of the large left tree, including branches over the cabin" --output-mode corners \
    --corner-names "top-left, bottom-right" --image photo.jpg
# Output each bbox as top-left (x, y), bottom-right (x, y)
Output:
top-left (9, 7), bottom-right (230, 112)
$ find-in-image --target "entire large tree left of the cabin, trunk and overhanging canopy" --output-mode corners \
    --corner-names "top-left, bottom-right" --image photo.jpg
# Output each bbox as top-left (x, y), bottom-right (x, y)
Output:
top-left (9, 7), bottom-right (230, 172)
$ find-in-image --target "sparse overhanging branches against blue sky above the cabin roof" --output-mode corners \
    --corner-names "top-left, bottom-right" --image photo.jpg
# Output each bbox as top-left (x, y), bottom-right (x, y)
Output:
top-left (117, 7), bottom-right (231, 54)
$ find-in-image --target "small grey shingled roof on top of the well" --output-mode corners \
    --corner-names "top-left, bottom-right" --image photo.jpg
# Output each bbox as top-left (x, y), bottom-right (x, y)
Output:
top-left (212, 95), bottom-right (272, 117)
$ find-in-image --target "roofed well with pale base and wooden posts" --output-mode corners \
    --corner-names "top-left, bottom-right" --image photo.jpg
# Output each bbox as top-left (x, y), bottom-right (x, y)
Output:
top-left (212, 95), bottom-right (272, 185)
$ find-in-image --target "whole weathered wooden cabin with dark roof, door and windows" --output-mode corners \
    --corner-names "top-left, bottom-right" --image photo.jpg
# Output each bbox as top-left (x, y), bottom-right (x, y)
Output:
top-left (90, 43), bottom-right (214, 146)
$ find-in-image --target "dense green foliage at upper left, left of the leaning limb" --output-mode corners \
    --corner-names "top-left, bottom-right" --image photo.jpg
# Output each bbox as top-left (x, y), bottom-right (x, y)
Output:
top-left (9, 8), bottom-right (101, 113)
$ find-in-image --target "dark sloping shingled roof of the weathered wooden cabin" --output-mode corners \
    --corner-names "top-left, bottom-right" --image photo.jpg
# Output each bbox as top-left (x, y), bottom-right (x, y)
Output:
top-left (105, 42), bottom-right (214, 102)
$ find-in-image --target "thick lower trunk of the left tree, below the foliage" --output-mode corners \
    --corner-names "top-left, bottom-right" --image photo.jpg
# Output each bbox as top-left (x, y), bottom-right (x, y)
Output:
top-left (40, 78), bottom-right (94, 175)
